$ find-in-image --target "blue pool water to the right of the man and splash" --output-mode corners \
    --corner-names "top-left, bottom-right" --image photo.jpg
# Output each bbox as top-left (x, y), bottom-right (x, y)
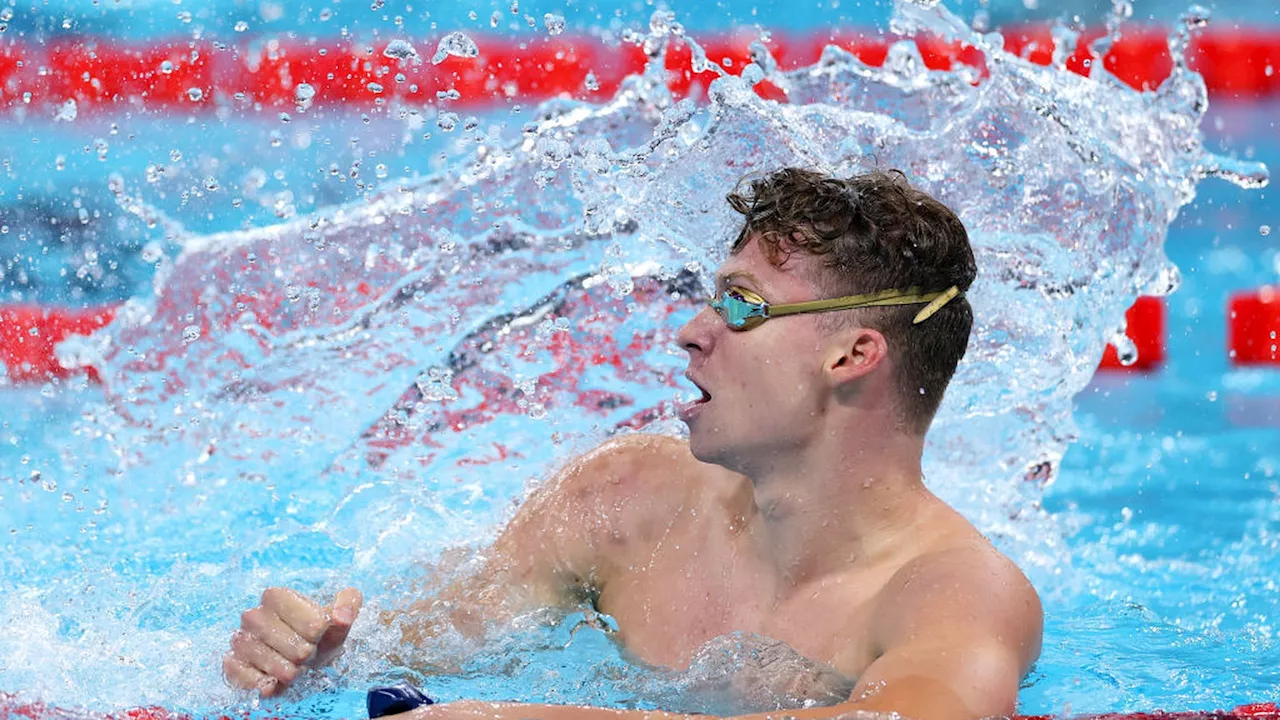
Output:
top-left (1021, 114), bottom-right (1280, 710)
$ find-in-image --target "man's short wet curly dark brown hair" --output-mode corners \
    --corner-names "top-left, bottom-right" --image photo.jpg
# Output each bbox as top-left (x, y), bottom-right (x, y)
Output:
top-left (728, 168), bottom-right (978, 434)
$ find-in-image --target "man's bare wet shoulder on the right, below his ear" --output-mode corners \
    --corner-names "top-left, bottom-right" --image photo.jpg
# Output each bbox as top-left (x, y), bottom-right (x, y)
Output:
top-left (876, 527), bottom-right (1043, 673)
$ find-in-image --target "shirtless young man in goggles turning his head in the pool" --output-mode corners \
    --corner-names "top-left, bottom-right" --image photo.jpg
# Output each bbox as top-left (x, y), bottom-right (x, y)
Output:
top-left (224, 169), bottom-right (1042, 720)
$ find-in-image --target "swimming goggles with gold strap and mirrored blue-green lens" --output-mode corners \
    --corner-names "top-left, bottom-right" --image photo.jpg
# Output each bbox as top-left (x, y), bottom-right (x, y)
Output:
top-left (710, 284), bottom-right (960, 331)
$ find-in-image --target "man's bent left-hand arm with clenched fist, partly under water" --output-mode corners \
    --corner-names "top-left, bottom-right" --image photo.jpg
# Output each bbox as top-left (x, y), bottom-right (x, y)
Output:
top-left (223, 436), bottom-right (678, 697)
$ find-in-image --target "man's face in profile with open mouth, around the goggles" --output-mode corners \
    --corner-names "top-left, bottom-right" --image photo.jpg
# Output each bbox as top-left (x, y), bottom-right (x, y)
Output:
top-left (678, 241), bottom-right (829, 471)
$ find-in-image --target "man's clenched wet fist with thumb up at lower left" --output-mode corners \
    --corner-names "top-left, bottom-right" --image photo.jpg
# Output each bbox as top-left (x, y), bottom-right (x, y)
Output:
top-left (223, 588), bottom-right (364, 697)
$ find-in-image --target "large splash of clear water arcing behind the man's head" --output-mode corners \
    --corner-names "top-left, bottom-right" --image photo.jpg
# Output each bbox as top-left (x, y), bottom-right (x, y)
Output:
top-left (0, 3), bottom-right (1267, 707)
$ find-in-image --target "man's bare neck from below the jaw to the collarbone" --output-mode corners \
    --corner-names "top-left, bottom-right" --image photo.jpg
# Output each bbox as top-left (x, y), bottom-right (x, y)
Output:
top-left (751, 420), bottom-right (933, 593)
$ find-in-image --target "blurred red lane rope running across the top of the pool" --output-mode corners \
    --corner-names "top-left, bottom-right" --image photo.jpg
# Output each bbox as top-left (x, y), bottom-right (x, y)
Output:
top-left (0, 26), bottom-right (1280, 114)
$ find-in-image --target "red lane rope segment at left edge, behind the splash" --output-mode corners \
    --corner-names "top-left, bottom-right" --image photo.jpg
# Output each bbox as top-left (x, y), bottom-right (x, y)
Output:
top-left (0, 305), bottom-right (115, 383)
